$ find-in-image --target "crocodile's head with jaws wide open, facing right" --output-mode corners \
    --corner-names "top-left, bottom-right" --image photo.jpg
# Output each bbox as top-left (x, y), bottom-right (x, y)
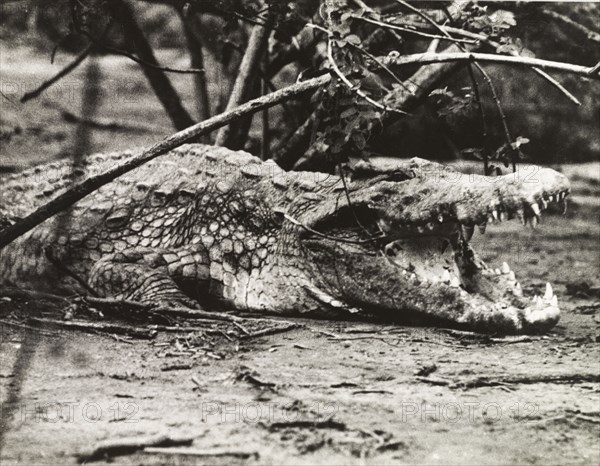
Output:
top-left (301, 162), bottom-right (569, 333)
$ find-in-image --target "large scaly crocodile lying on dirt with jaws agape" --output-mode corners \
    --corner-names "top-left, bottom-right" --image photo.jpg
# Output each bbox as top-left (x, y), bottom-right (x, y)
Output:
top-left (0, 144), bottom-right (570, 333)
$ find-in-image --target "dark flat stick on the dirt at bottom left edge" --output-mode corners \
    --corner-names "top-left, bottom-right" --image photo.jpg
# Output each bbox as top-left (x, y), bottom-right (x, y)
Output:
top-left (77, 435), bottom-right (194, 463)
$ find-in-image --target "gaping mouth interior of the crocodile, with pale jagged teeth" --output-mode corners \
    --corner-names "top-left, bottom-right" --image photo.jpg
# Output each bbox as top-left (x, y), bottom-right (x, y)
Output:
top-left (384, 191), bottom-right (568, 332)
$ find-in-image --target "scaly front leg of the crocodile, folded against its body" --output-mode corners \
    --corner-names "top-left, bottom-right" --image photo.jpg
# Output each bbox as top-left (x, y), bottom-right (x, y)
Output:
top-left (89, 248), bottom-right (209, 307)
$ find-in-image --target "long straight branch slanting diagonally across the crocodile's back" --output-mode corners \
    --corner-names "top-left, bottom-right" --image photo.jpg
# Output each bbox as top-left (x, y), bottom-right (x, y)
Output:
top-left (0, 74), bottom-right (331, 249)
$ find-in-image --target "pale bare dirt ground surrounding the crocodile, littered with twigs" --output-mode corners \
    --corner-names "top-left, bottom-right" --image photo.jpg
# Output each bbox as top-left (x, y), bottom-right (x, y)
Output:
top-left (0, 47), bottom-right (600, 465)
